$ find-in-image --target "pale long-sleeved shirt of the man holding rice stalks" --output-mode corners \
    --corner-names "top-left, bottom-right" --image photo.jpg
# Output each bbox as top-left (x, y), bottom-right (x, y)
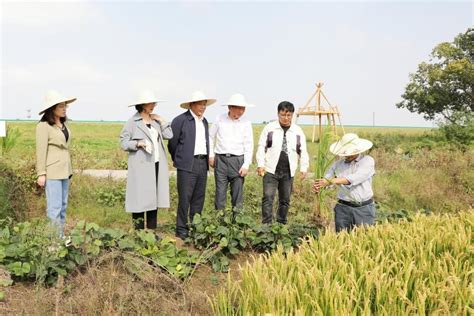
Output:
top-left (325, 155), bottom-right (375, 203)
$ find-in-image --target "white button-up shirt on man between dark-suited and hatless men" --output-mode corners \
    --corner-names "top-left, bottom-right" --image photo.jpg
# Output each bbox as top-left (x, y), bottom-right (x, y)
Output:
top-left (209, 113), bottom-right (253, 169)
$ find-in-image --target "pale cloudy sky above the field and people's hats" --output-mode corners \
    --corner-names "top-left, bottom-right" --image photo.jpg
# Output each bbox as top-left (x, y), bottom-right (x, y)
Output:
top-left (0, 0), bottom-right (473, 126)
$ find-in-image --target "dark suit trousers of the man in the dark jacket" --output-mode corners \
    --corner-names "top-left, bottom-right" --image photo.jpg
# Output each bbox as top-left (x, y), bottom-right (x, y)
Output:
top-left (176, 158), bottom-right (208, 236)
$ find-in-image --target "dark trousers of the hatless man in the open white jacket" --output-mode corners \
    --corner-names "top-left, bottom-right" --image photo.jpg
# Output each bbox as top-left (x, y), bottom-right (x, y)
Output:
top-left (262, 172), bottom-right (293, 224)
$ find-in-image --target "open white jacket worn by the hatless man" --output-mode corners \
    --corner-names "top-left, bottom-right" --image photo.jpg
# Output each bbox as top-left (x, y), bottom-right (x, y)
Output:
top-left (256, 121), bottom-right (309, 177)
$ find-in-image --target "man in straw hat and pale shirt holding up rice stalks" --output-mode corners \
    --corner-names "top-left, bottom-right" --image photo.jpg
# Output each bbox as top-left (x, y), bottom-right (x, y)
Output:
top-left (313, 133), bottom-right (375, 232)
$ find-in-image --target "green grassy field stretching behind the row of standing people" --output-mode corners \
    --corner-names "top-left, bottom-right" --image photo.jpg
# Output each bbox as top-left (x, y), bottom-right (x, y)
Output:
top-left (2, 122), bottom-right (474, 227)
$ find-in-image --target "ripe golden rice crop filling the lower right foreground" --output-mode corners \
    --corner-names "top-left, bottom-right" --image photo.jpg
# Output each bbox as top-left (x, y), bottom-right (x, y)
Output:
top-left (212, 212), bottom-right (474, 315)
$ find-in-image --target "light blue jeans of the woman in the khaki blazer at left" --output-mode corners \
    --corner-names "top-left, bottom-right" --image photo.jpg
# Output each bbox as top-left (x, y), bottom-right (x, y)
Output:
top-left (45, 179), bottom-right (69, 237)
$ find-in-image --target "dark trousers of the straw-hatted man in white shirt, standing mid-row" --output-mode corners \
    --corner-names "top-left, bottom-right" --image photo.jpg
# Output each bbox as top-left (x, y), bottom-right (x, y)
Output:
top-left (214, 155), bottom-right (245, 210)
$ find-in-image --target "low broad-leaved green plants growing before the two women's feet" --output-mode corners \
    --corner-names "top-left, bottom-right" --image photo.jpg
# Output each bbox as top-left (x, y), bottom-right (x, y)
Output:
top-left (0, 221), bottom-right (200, 285)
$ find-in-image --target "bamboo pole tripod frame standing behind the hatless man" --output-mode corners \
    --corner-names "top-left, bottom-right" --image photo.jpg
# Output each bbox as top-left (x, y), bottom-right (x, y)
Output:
top-left (296, 82), bottom-right (344, 143)
